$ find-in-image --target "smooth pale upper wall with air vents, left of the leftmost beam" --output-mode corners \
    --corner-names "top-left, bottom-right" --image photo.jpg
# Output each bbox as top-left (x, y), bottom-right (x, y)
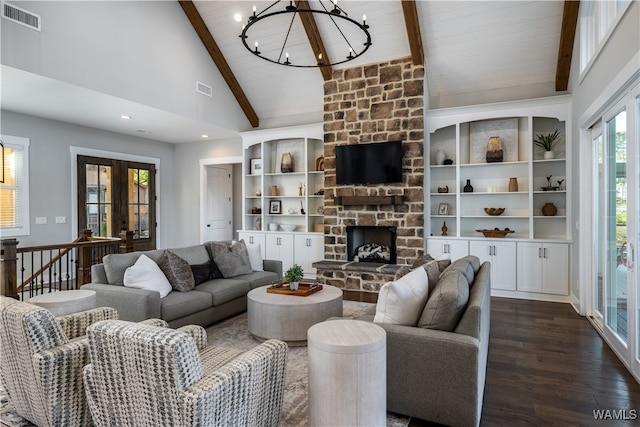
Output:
top-left (0, 1), bottom-right (251, 131)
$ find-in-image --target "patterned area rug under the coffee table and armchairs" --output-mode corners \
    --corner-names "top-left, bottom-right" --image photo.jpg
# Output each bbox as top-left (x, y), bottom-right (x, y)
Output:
top-left (0, 301), bottom-right (409, 427)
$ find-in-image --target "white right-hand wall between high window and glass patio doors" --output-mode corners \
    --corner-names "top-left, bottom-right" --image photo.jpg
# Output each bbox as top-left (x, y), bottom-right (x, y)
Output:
top-left (569, 1), bottom-right (640, 308)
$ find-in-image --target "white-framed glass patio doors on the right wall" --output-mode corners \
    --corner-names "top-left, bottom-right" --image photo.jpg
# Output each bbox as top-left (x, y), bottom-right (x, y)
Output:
top-left (590, 86), bottom-right (640, 378)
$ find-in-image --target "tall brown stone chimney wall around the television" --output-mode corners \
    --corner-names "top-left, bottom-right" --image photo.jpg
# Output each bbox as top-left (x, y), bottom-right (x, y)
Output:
top-left (324, 58), bottom-right (425, 265)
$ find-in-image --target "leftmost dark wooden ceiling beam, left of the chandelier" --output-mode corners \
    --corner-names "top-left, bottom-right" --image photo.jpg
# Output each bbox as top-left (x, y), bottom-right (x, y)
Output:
top-left (179, 1), bottom-right (260, 127)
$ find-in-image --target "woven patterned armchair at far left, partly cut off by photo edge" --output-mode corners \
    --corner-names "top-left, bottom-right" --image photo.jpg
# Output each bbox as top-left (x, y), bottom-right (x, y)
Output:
top-left (0, 296), bottom-right (118, 427)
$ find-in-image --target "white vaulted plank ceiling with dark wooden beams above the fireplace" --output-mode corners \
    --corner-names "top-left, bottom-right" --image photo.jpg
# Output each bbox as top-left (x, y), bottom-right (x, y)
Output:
top-left (180, 0), bottom-right (579, 127)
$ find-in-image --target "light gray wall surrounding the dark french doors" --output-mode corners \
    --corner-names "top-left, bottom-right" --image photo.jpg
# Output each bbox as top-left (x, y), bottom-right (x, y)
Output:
top-left (1, 111), bottom-right (178, 247)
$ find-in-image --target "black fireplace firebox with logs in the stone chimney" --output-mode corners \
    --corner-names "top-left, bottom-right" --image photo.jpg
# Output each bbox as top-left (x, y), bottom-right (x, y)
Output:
top-left (347, 225), bottom-right (397, 264)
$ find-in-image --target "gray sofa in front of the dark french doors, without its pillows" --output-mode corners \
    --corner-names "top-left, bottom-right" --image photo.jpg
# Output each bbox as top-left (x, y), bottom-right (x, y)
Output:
top-left (82, 242), bottom-right (282, 328)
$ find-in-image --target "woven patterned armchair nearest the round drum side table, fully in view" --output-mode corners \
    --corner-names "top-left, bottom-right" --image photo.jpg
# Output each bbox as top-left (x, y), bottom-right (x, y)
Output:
top-left (84, 321), bottom-right (287, 427)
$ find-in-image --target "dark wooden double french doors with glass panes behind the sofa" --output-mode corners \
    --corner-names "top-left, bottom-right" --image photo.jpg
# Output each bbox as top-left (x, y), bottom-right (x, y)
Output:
top-left (77, 156), bottom-right (156, 250)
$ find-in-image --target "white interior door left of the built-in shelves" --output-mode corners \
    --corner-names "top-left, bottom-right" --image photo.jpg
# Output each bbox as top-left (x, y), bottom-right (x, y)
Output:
top-left (204, 165), bottom-right (233, 241)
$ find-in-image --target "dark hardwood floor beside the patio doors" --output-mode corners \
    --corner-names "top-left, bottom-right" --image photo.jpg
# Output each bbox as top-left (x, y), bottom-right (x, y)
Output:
top-left (410, 298), bottom-right (640, 427)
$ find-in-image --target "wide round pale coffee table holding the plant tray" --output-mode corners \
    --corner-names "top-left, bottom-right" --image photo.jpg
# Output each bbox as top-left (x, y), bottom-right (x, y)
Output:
top-left (247, 285), bottom-right (342, 346)
